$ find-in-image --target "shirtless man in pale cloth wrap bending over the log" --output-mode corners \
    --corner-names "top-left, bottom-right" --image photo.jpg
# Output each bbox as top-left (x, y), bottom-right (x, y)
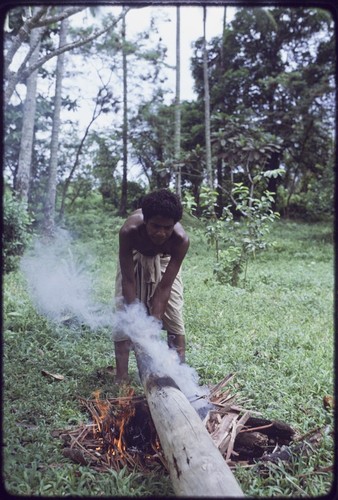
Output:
top-left (115, 189), bottom-right (189, 382)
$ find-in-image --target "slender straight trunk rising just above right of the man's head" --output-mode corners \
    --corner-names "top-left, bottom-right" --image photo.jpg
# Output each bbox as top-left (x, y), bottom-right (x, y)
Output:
top-left (175, 6), bottom-right (182, 198)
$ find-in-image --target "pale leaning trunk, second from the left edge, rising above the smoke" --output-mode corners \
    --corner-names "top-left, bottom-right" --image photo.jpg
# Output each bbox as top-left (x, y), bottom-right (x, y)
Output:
top-left (43, 15), bottom-right (68, 236)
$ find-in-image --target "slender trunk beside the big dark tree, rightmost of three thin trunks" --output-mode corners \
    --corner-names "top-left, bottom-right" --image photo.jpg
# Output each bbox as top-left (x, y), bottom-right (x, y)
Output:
top-left (203, 6), bottom-right (213, 188)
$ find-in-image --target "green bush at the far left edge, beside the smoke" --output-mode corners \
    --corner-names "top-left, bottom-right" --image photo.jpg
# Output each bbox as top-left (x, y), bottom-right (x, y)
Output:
top-left (2, 191), bottom-right (33, 272)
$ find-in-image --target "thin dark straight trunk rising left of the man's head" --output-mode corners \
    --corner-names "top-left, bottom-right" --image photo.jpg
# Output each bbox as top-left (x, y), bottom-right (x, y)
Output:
top-left (119, 6), bottom-right (128, 216)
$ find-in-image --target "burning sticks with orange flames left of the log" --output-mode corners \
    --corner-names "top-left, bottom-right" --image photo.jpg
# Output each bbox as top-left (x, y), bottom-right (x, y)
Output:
top-left (59, 389), bottom-right (166, 472)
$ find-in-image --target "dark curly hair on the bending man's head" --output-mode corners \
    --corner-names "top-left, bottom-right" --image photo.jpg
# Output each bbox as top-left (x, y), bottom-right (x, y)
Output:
top-left (141, 189), bottom-right (183, 223)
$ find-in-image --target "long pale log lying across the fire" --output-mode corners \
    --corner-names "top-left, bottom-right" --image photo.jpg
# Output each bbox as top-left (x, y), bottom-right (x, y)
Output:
top-left (134, 343), bottom-right (244, 497)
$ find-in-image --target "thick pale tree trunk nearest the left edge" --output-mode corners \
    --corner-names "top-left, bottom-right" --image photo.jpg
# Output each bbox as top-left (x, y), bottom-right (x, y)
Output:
top-left (14, 16), bottom-right (41, 204)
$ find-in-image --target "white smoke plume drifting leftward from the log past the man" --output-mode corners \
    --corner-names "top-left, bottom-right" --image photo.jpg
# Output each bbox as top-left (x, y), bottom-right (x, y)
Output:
top-left (21, 230), bottom-right (205, 397)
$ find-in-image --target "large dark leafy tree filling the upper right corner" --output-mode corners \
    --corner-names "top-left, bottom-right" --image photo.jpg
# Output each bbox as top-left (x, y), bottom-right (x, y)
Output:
top-left (193, 8), bottom-right (334, 217)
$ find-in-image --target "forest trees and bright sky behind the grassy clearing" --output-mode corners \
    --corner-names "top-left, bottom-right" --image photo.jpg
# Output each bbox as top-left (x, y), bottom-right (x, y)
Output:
top-left (3, 6), bottom-right (335, 264)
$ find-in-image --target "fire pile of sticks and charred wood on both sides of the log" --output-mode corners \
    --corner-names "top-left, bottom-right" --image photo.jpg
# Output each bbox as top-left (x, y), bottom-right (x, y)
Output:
top-left (53, 374), bottom-right (295, 472)
